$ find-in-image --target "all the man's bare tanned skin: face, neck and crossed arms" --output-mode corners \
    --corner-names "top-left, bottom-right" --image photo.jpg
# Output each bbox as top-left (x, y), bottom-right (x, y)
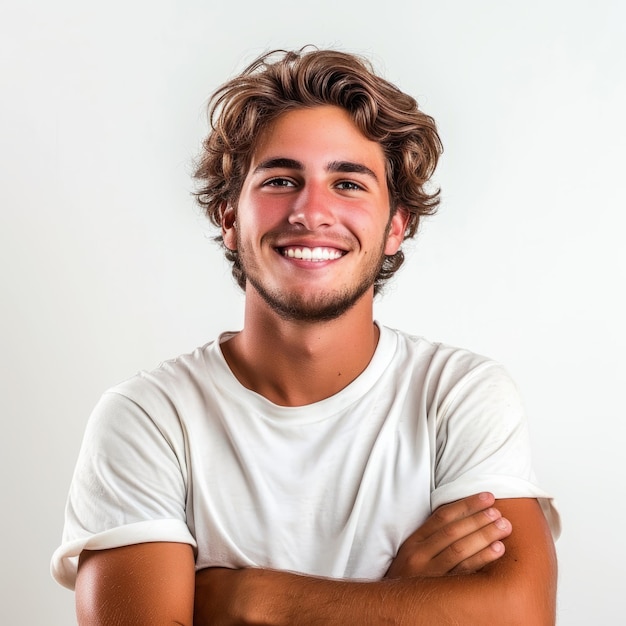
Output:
top-left (76, 107), bottom-right (556, 626)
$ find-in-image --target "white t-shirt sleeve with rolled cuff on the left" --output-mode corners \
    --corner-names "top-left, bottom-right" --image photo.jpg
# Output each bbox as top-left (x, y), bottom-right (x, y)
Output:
top-left (51, 391), bottom-right (196, 589)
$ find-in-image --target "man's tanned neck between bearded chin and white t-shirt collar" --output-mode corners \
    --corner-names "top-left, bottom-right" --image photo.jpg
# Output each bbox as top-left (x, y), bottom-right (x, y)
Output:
top-left (222, 292), bottom-right (379, 406)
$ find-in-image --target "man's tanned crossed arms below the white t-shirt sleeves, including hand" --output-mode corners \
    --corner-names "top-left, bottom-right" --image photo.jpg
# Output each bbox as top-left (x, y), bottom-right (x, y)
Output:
top-left (76, 494), bottom-right (556, 626)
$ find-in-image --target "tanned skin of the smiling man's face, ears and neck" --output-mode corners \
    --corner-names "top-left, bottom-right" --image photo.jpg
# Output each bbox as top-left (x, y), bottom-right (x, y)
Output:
top-left (222, 106), bottom-right (407, 406)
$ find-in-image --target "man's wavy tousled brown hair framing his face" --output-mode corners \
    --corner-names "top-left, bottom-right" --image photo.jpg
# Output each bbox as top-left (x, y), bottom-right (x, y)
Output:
top-left (194, 46), bottom-right (443, 293)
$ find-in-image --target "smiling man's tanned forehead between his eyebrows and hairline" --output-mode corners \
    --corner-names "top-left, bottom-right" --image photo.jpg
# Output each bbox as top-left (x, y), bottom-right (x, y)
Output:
top-left (250, 105), bottom-right (385, 169)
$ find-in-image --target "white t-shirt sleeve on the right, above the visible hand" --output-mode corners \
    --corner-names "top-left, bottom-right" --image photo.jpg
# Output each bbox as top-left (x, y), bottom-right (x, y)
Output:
top-left (431, 362), bottom-right (561, 538)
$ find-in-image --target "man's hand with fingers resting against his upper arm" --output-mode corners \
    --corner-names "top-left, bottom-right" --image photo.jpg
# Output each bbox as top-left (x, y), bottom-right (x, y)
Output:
top-left (385, 493), bottom-right (512, 578)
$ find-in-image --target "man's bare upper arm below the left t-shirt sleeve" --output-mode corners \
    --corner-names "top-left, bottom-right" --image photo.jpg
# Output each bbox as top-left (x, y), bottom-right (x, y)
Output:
top-left (76, 543), bottom-right (195, 626)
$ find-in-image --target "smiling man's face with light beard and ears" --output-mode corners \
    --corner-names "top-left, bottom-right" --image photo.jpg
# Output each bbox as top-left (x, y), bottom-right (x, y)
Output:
top-left (223, 106), bottom-right (406, 321)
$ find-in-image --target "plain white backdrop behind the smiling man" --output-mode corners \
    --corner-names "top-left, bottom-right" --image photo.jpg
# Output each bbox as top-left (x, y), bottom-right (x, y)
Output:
top-left (0, 0), bottom-right (626, 626)
